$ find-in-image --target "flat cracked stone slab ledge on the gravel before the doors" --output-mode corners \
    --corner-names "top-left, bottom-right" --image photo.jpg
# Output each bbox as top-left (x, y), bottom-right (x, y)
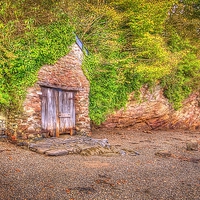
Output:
top-left (25, 136), bottom-right (139, 156)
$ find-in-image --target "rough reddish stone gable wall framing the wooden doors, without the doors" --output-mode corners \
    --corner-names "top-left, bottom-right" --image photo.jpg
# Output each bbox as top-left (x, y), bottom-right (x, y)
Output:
top-left (8, 44), bottom-right (90, 139)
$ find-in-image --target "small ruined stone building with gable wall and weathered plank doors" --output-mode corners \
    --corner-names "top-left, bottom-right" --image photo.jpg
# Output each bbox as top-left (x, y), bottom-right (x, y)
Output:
top-left (8, 44), bottom-right (90, 139)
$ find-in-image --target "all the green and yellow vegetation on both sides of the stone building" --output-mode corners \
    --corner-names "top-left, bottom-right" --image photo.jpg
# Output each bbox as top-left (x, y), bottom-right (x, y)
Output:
top-left (0, 0), bottom-right (200, 124)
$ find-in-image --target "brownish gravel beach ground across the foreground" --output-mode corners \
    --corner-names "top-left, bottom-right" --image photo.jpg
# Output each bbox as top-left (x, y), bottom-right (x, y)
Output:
top-left (0, 130), bottom-right (200, 200)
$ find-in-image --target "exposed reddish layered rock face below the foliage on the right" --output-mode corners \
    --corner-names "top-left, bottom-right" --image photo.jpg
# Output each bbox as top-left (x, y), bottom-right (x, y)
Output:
top-left (101, 86), bottom-right (200, 130)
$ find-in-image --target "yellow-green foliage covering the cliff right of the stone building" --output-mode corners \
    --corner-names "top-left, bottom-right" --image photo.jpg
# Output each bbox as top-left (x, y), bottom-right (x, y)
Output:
top-left (69, 0), bottom-right (199, 124)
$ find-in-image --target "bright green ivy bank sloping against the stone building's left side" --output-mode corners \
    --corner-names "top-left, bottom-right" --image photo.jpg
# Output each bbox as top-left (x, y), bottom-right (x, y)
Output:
top-left (0, 17), bottom-right (74, 110)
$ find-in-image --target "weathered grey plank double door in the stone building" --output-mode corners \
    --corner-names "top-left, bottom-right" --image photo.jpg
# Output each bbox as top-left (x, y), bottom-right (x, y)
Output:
top-left (41, 87), bottom-right (75, 137)
